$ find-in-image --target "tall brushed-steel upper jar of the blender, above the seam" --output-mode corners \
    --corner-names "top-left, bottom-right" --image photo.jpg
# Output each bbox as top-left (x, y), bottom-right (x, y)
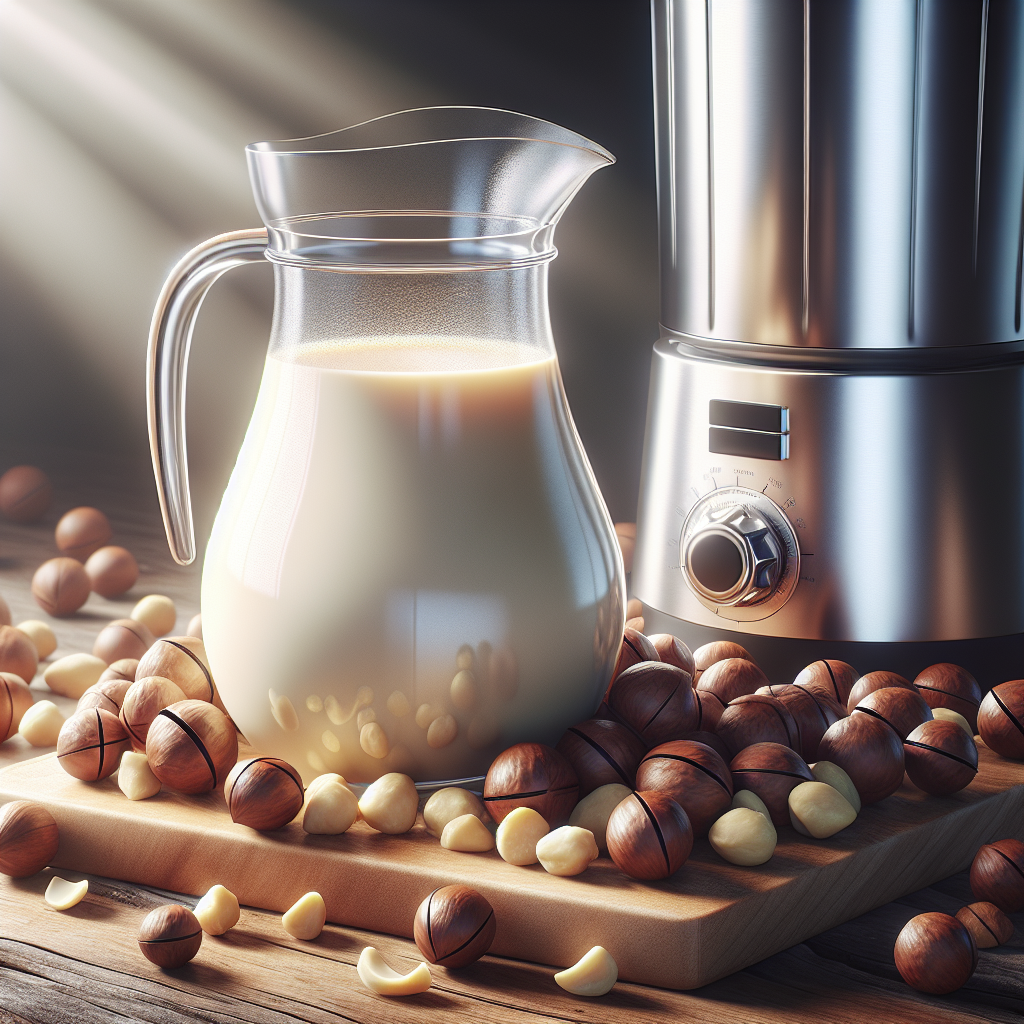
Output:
top-left (653, 0), bottom-right (1024, 349)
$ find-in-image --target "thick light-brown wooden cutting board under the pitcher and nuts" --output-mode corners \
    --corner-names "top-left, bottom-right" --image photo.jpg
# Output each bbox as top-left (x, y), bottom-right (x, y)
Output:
top-left (0, 746), bottom-right (1024, 989)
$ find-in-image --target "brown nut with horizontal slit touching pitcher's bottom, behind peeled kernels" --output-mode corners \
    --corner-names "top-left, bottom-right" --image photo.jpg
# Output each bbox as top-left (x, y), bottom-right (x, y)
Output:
top-left (483, 743), bottom-right (580, 827)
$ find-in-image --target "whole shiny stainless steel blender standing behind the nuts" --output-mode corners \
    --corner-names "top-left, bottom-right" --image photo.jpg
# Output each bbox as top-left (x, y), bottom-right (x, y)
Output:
top-left (633, 0), bottom-right (1024, 684)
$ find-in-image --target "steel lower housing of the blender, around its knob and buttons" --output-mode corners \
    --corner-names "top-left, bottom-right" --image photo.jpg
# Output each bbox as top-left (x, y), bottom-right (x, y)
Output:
top-left (633, 339), bottom-right (1024, 642)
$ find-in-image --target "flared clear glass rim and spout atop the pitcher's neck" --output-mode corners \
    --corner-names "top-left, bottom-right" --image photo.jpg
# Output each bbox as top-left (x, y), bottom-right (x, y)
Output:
top-left (246, 106), bottom-right (614, 271)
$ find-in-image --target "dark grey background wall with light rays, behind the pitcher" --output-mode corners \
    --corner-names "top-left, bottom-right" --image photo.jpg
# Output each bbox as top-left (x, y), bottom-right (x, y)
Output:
top-left (0, 0), bottom-right (657, 536)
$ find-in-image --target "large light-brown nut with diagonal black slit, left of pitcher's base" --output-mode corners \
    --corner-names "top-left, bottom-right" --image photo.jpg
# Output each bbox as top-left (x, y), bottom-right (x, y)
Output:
top-left (145, 700), bottom-right (239, 794)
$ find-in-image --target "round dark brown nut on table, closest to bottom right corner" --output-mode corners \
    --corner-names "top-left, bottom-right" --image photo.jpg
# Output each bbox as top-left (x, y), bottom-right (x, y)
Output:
top-left (893, 913), bottom-right (978, 995)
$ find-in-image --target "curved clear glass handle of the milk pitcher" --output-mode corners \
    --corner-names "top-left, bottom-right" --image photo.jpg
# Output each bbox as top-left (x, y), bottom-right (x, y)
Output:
top-left (145, 227), bottom-right (267, 565)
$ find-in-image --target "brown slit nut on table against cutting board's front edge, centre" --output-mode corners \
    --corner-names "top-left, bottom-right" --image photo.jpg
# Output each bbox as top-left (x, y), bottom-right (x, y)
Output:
top-left (413, 886), bottom-right (497, 970)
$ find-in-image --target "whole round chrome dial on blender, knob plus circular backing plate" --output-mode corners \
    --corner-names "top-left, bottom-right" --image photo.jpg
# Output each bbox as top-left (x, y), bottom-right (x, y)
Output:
top-left (679, 487), bottom-right (800, 621)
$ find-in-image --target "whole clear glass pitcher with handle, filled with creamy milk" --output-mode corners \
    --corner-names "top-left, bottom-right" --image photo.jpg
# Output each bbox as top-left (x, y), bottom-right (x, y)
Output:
top-left (147, 108), bottom-right (625, 785)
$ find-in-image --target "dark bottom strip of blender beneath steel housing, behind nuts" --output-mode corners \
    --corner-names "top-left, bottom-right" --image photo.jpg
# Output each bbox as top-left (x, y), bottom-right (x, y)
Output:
top-left (643, 605), bottom-right (1024, 691)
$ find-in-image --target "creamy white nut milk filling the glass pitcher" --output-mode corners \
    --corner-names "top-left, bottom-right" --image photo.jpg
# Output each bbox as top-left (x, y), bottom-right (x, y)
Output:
top-left (203, 339), bottom-right (622, 781)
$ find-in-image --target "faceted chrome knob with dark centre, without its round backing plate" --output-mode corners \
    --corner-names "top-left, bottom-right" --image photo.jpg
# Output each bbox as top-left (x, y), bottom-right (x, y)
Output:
top-left (682, 504), bottom-right (785, 606)
